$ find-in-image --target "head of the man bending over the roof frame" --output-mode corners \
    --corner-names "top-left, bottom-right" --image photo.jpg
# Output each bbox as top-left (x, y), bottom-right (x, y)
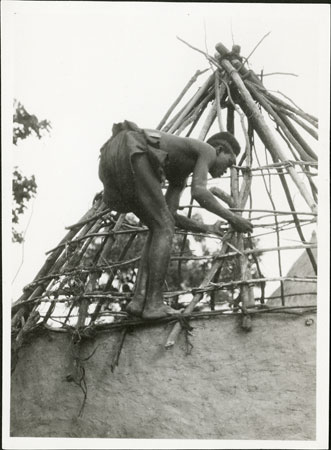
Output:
top-left (207, 131), bottom-right (240, 178)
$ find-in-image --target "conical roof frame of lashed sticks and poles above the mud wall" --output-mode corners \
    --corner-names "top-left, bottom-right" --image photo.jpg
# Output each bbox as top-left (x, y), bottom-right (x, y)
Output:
top-left (12, 40), bottom-right (318, 364)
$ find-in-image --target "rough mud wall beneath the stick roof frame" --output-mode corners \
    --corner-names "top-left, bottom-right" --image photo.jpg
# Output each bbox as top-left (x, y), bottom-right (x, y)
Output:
top-left (11, 313), bottom-right (316, 440)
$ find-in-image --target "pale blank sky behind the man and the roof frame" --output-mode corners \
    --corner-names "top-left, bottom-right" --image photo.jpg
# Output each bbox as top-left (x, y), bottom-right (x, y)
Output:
top-left (2, 1), bottom-right (328, 299)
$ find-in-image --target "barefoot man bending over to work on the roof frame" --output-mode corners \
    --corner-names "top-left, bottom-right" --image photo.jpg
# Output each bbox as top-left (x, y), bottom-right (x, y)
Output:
top-left (99, 121), bottom-right (253, 319)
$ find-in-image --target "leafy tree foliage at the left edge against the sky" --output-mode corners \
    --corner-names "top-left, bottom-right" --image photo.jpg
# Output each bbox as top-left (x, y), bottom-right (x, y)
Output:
top-left (12, 100), bottom-right (51, 243)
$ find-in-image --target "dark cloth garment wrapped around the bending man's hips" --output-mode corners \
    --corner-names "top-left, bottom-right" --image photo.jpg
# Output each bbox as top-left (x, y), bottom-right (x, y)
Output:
top-left (99, 120), bottom-right (168, 212)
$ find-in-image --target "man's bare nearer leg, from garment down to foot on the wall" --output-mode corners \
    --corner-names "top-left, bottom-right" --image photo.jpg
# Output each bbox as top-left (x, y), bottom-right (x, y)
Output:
top-left (132, 154), bottom-right (178, 319)
